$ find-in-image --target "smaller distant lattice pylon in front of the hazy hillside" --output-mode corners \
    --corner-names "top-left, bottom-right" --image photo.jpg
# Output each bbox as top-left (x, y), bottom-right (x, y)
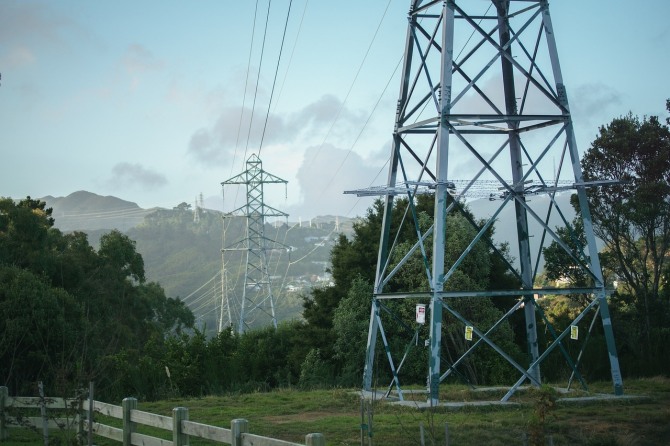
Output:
top-left (221, 154), bottom-right (288, 333)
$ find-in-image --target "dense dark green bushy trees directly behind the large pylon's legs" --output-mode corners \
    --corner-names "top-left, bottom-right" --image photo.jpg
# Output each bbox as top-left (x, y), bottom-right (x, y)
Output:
top-left (304, 195), bottom-right (523, 386)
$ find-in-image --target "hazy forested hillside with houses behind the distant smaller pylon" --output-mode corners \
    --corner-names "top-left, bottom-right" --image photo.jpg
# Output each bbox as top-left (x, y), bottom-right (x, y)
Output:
top-left (126, 206), bottom-right (351, 328)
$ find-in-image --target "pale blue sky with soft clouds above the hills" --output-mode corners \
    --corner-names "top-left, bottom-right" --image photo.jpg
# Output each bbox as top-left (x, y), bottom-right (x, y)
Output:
top-left (0, 0), bottom-right (670, 221)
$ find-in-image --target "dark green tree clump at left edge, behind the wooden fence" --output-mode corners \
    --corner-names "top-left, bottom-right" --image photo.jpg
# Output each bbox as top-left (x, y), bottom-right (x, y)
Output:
top-left (0, 197), bottom-right (193, 395)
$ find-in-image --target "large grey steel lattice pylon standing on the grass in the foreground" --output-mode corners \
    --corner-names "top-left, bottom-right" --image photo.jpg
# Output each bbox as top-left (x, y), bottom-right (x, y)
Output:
top-left (347, 0), bottom-right (623, 404)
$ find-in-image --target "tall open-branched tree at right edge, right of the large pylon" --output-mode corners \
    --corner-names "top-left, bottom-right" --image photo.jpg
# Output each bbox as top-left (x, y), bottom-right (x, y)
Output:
top-left (584, 102), bottom-right (670, 343)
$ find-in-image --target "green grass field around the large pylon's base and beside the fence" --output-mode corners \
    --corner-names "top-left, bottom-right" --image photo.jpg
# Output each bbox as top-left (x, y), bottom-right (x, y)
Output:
top-left (2, 377), bottom-right (670, 446)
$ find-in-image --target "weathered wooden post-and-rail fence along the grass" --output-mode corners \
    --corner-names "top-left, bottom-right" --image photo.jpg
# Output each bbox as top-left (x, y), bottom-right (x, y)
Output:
top-left (0, 387), bottom-right (326, 446)
